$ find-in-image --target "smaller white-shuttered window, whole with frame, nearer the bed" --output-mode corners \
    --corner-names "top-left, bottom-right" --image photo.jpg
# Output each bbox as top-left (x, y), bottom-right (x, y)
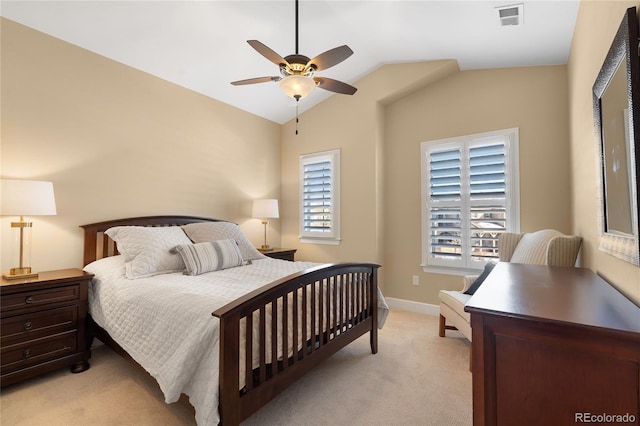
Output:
top-left (300, 150), bottom-right (340, 245)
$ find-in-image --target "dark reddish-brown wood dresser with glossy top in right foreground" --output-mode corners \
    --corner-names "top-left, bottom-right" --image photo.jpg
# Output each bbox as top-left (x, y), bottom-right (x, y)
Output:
top-left (465, 263), bottom-right (640, 425)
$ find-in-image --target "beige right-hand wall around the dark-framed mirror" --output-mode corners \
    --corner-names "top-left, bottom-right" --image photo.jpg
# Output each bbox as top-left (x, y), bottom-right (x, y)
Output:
top-left (568, 1), bottom-right (640, 303)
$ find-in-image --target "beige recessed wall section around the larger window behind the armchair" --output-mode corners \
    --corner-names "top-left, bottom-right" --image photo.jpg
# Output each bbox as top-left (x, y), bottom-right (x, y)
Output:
top-left (384, 66), bottom-right (571, 304)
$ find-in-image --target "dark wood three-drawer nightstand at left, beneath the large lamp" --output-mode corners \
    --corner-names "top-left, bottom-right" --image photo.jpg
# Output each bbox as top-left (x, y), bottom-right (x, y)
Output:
top-left (0, 269), bottom-right (93, 386)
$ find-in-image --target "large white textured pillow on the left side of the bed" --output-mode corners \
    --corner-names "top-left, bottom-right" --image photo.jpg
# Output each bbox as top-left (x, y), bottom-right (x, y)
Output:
top-left (105, 226), bottom-right (191, 280)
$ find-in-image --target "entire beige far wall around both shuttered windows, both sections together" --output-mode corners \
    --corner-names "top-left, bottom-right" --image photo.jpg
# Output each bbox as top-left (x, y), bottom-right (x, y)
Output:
top-left (282, 61), bottom-right (571, 304)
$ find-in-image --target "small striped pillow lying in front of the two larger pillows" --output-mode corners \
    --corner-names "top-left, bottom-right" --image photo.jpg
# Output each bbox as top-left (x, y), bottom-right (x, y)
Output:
top-left (173, 240), bottom-right (243, 275)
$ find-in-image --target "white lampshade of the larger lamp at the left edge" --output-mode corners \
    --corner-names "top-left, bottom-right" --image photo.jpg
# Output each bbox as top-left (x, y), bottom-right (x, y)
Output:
top-left (0, 179), bottom-right (56, 216)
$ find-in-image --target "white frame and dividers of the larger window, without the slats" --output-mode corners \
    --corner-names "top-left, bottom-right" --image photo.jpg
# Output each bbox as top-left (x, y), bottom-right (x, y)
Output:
top-left (420, 128), bottom-right (520, 275)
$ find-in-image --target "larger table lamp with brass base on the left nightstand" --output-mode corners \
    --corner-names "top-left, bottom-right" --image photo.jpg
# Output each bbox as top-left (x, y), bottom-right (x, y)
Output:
top-left (0, 179), bottom-right (56, 280)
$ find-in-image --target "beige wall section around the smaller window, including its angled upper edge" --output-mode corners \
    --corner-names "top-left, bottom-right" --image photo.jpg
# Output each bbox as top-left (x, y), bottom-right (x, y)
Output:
top-left (281, 60), bottom-right (458, 270)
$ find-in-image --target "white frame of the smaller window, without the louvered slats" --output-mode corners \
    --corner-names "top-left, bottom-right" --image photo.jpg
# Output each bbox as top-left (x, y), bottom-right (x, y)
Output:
top-left (298, 149), bottom-right (340, 245)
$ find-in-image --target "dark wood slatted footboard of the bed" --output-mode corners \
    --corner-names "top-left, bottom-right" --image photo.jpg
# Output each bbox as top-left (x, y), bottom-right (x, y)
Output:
top-left (213, 263), bottom-right (379, 425)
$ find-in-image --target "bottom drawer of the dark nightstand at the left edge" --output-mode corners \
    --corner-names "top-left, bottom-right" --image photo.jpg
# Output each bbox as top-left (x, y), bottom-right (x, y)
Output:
top-left (1, 330), bottom-right (77, 374)
